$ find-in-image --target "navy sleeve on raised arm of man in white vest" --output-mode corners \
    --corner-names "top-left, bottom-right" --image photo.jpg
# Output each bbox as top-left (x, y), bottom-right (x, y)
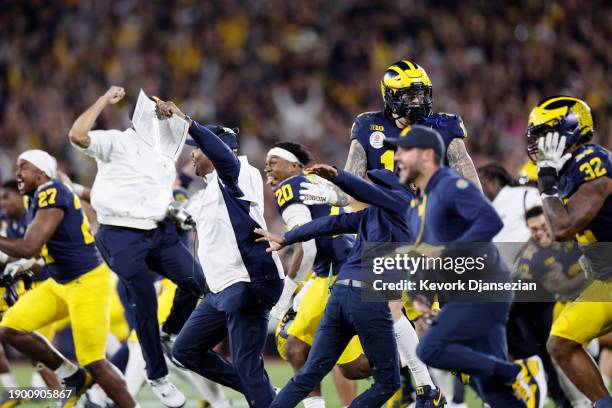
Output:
top-left (189, 120), bottom-right (240, 187)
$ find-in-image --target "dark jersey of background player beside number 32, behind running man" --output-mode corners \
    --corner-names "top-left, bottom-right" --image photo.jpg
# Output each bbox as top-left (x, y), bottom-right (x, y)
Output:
top-left (516, 241), bottom-right (582, 301)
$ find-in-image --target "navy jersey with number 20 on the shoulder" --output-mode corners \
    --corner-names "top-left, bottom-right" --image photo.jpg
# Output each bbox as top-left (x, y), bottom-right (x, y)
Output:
top-left (274, 174), bottom-right (355, 276)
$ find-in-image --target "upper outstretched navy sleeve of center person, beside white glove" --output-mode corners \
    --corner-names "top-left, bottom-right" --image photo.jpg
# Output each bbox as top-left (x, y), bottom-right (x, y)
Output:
top-left (331, 169), bottom-right (410, 214)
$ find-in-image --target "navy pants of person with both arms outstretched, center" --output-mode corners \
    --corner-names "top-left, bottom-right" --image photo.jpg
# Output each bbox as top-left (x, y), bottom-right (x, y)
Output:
top-left (270, 285), bottom-right (400, 408)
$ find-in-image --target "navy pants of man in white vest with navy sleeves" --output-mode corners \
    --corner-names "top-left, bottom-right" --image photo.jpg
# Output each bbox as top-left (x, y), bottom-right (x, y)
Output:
top-left (172, 279), bottom-right (283, 408)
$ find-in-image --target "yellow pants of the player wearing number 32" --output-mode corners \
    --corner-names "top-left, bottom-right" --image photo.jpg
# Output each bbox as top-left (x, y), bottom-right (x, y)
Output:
top-left (550, 280), bottom-right (612, 345)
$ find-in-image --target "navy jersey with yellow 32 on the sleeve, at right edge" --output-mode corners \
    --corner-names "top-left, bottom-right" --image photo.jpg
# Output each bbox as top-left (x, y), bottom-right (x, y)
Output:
top-left (558, 144), bottom-right (612, 279)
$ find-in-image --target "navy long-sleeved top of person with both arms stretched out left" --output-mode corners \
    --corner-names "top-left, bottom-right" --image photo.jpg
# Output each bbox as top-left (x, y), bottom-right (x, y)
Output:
top-left (285, 170), bottom-right (414, 281)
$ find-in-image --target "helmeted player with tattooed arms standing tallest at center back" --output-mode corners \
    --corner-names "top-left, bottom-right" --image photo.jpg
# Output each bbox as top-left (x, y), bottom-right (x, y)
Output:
top-left (307, 60), bottom-right (480, 406)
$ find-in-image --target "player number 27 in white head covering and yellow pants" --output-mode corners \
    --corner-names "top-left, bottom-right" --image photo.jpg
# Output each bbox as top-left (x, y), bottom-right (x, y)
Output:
top-left (0, 150), bottom-right (137, 408)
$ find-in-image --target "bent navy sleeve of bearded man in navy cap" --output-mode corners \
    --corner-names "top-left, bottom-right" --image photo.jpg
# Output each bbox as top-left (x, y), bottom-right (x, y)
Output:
top-left (447, 179), bottom-right (504, 242)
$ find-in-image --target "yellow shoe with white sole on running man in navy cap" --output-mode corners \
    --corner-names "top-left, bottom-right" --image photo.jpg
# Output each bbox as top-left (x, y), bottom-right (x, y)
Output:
top-left (512, 356), bottom-right (548, 408)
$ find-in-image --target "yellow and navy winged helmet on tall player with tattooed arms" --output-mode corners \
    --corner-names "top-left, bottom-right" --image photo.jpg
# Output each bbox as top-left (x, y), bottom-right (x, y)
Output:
top-left (380, 60), bottom-right (433, 124)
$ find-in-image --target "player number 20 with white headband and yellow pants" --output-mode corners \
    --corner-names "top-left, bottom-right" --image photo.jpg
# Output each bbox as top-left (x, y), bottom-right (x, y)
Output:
top-left (264, 142), bottom-right (369, 408)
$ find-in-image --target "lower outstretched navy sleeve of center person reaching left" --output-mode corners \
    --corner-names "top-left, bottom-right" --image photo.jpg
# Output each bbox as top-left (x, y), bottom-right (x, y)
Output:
top-left (285, 209), bottom-right (367, 245)
